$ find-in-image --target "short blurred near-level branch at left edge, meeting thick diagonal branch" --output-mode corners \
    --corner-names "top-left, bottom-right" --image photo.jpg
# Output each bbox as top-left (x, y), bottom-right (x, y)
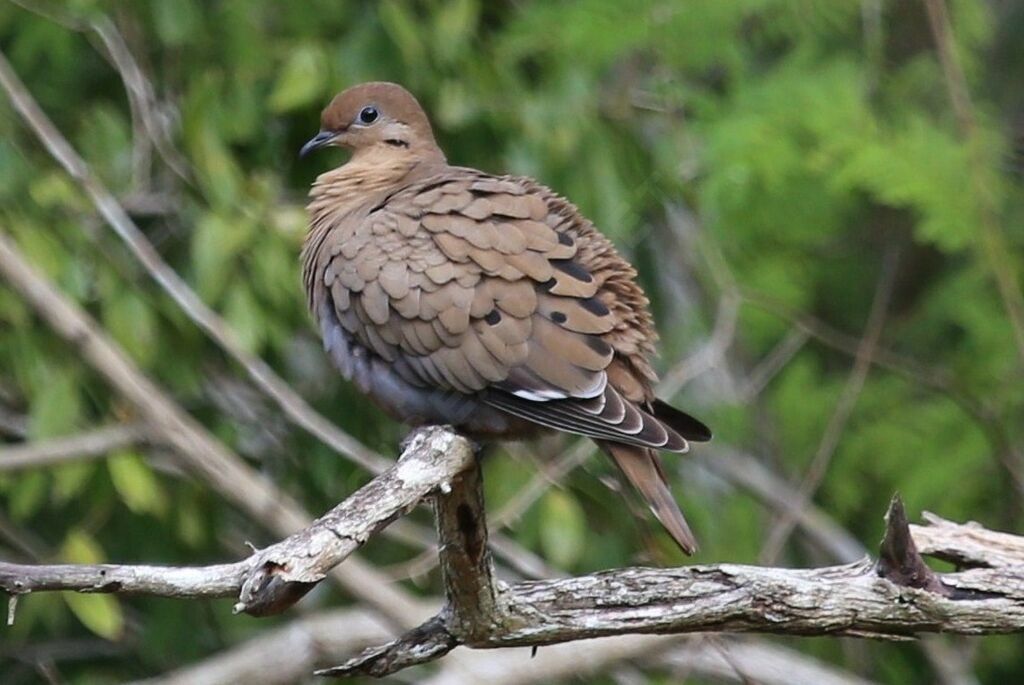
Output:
top-left (0, 423), bottom-right (148, 473)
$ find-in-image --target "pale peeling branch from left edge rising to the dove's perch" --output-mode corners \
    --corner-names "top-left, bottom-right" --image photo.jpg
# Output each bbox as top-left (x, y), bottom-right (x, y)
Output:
top-left (0, 428), bottom-right (474, 615)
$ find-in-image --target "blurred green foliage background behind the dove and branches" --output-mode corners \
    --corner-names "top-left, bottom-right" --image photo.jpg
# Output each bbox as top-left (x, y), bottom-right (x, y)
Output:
top-left (0, 0), bottom-right (1024, 683)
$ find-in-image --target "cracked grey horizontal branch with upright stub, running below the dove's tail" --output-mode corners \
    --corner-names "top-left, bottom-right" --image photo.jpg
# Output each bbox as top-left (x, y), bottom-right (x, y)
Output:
top-left (319, 485), bottom-right (1024, 676)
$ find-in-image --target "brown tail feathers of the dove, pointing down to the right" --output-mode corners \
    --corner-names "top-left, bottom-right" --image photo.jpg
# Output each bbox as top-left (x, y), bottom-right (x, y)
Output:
top-left (598, 440), bottom-right (697, 554)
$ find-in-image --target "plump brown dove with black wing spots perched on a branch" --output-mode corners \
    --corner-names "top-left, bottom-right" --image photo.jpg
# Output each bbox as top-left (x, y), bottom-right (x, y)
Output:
top-left (300, 82), bottom-right (711, 554)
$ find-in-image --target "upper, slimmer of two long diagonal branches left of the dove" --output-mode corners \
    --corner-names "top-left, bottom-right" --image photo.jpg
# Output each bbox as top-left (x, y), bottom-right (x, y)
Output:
top-left (0, 52), bottom-right (389, 473)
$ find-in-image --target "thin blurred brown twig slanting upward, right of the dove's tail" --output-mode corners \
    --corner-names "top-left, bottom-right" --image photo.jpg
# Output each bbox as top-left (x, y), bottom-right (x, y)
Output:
top-left (761, 248), bottom-right (899, 564)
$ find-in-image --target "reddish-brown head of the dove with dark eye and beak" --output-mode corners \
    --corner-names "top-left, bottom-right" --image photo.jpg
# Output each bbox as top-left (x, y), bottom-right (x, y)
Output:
top-left (299, 81), bottom-right (439, 157)
